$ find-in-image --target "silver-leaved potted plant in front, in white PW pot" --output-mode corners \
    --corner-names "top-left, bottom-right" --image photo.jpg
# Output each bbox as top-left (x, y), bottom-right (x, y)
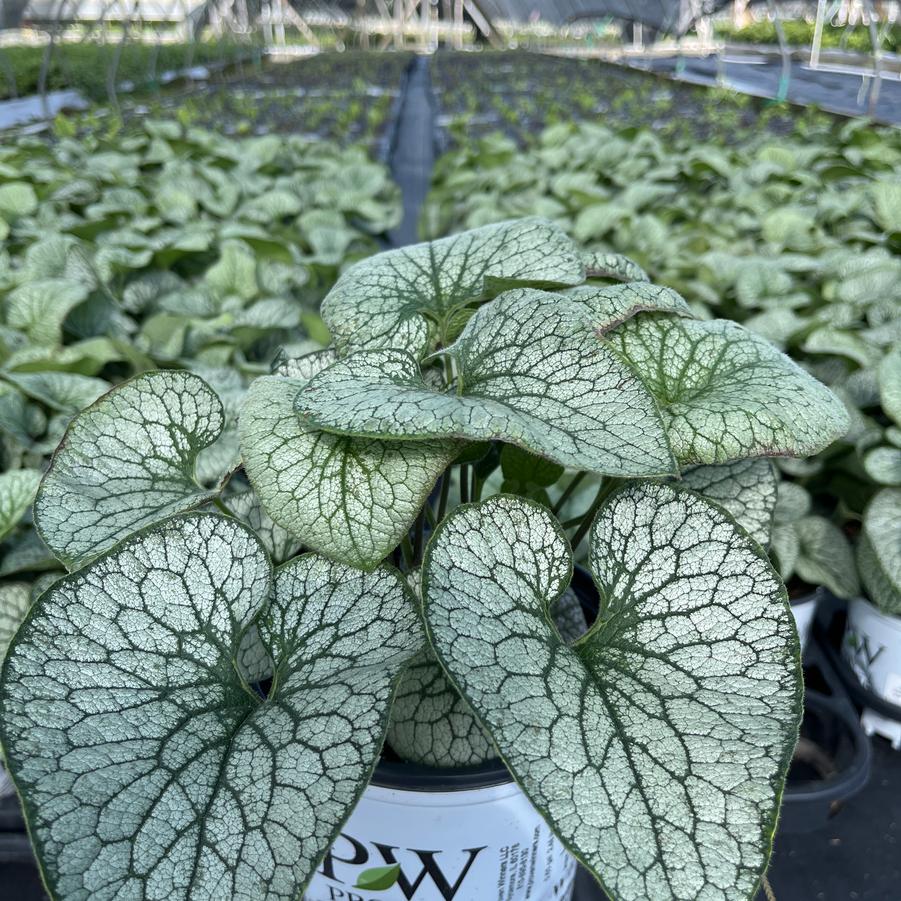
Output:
top-left (0, 219), bottom-right (848, 901)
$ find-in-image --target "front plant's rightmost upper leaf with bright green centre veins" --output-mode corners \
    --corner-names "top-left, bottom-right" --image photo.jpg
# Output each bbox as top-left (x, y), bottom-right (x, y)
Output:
top-left (608, 314), bottom-right (849, 463)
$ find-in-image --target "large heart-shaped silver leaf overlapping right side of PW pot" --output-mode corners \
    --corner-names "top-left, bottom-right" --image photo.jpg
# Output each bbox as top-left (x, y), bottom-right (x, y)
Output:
top-left (423, 483), bottom-right (801, 901)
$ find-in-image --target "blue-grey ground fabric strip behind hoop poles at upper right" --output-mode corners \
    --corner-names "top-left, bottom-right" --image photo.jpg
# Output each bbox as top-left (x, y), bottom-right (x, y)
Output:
top-left (632, 54), bottom-right (901, 125)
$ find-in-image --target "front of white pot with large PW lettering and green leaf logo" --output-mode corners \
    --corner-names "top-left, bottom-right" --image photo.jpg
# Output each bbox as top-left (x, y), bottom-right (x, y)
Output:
top-left (304, 783), bottom-right (576, 901)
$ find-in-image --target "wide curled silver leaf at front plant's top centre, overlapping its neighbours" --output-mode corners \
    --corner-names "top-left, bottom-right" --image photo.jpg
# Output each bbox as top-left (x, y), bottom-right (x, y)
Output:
top-left (296, 289), bottom-right (674, 476)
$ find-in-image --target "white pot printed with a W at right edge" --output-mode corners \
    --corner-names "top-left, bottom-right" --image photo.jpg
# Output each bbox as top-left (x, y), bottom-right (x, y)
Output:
top-left (842, 598), bottom-right (901, 707)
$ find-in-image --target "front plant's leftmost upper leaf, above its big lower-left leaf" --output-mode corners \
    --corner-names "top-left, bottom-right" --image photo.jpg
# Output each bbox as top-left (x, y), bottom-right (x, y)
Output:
top-left (35, 371), bottom-right (224, 569)
